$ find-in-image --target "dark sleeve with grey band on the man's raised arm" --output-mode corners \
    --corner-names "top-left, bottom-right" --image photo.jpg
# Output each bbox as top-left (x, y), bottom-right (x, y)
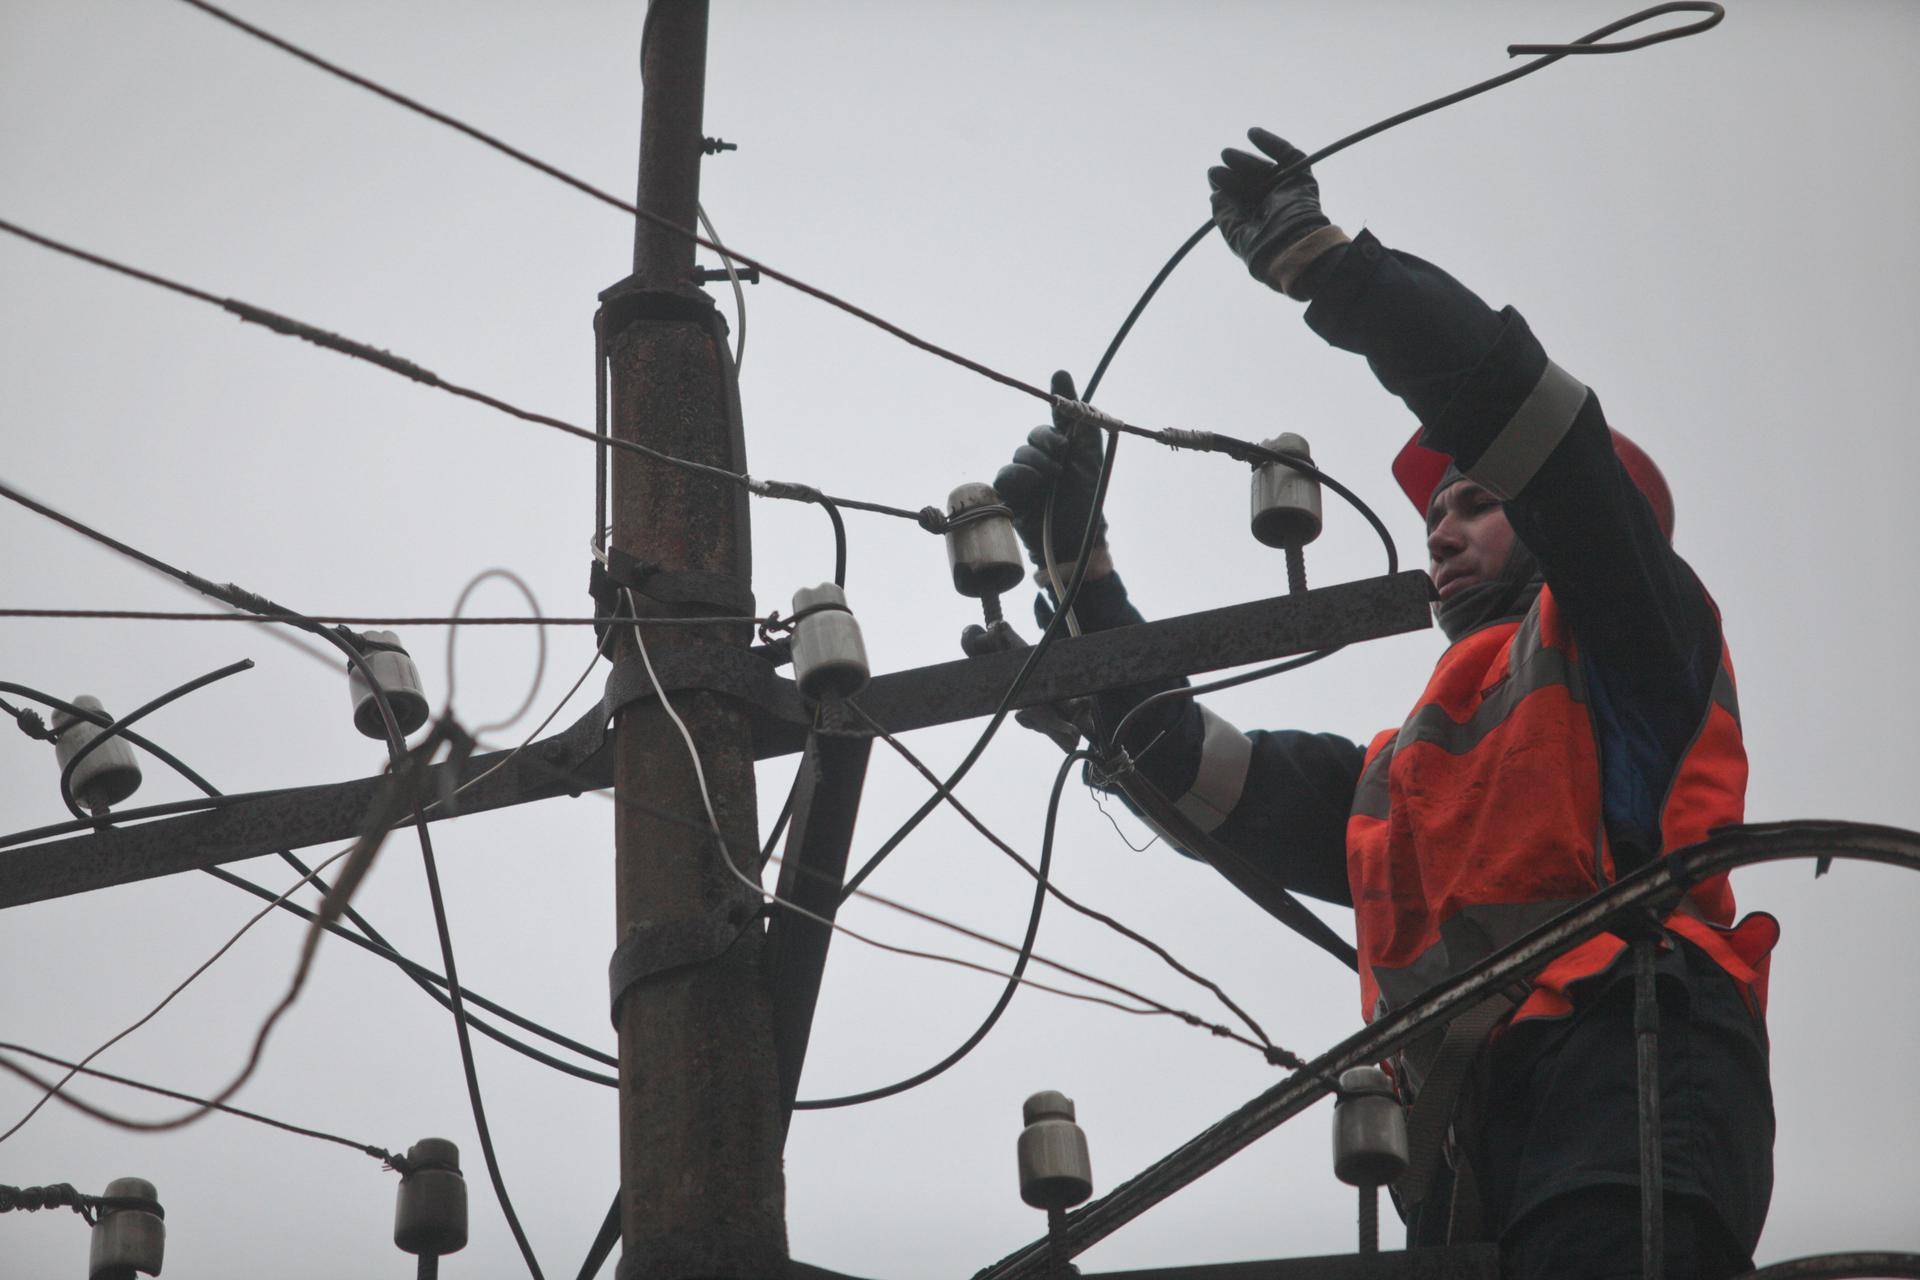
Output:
top-left (1306, 232), bottom-right (1720, 850)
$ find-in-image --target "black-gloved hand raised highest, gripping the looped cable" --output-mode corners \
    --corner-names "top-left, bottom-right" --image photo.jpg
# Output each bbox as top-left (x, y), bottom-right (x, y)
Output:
top-left (1206, 127), bottom-right (1346, 297)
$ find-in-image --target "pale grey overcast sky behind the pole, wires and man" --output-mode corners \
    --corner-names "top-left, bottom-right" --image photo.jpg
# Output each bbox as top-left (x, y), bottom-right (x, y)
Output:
top-left (0, 0), bottom-right (1920, 1280)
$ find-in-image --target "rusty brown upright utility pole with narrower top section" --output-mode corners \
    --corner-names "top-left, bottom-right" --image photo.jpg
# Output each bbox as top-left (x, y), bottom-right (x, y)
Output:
top-left (601, 0), bottom-right (787, 1280)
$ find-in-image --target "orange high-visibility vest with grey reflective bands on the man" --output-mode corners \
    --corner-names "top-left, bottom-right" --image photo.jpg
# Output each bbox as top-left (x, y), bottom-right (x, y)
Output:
top-left (1346, 587), bottom-right (1780, 1021)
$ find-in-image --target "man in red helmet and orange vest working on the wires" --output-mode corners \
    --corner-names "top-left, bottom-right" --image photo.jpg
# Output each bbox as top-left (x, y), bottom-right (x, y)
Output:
top-left (995, 129), bottom-right (1778, 1280)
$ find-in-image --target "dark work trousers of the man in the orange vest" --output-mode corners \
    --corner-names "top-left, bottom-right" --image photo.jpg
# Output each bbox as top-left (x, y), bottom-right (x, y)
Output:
top-left (1407, 938), bottom-right (1774, 1280)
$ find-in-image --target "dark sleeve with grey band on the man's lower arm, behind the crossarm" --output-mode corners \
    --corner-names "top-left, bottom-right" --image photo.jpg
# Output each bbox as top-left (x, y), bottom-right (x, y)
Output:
top-left (1052, 574), bottom-right (1365, 906)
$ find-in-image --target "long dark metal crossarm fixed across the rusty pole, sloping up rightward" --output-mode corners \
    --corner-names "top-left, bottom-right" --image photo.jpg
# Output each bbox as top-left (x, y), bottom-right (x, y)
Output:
top-left (0, 572), bottom-right (1432, 908)
